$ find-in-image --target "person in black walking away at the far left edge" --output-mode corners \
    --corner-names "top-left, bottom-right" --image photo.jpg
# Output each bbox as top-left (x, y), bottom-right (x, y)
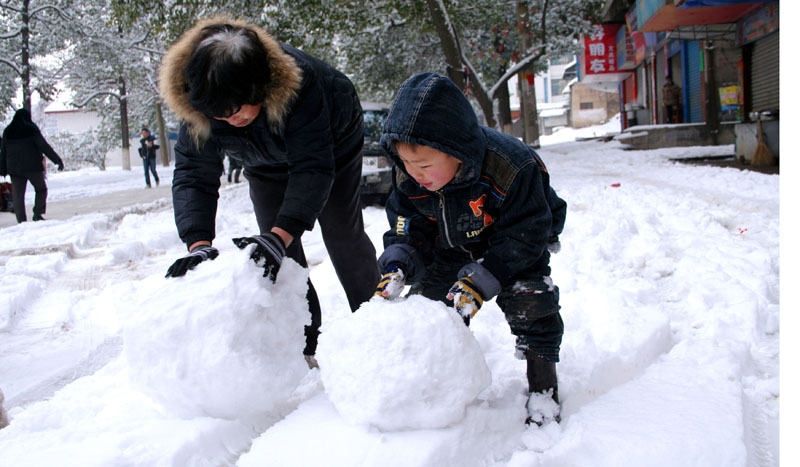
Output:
top-left (0, 108), bottom-right (64, 223)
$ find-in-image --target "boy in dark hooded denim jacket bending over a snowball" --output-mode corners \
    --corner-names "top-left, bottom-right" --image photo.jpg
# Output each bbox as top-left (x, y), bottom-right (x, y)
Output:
top-left (375, 73), bottom-right (567, 424)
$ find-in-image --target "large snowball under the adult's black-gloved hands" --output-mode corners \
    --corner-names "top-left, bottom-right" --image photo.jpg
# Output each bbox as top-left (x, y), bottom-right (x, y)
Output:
top-left (121, 250), bottom-right (311, 419)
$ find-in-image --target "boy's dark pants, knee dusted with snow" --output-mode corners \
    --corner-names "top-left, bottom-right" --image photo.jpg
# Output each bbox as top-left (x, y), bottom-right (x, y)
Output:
top-left (410, 250), bottom-right (564, 362)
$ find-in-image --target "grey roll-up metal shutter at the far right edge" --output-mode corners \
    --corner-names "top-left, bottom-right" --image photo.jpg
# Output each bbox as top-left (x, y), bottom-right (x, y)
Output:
top-left (750, 32), bottom-right (780, 112)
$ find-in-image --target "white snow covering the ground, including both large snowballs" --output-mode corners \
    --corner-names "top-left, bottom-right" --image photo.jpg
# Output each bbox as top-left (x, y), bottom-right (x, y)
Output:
top-left (0, 121), bottom-right (790, 467)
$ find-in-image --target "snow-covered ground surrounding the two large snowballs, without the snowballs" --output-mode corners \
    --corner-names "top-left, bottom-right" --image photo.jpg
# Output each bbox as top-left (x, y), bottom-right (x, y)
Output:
top-left (0, 142), bottom-right (780, 467)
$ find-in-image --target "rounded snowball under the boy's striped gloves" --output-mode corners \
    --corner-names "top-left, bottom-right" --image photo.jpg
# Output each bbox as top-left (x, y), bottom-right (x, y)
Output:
top-left (317, 296), bottom-right (491, 431)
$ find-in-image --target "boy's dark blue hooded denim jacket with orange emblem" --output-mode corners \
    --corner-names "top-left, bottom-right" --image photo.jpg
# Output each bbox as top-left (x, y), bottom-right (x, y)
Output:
top-left (378, 73), bottom-right (567, 298)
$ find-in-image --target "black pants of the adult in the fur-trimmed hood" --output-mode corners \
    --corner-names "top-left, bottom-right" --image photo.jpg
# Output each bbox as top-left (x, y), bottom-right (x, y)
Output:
top-left (244, 157), bottom-right (379, 355)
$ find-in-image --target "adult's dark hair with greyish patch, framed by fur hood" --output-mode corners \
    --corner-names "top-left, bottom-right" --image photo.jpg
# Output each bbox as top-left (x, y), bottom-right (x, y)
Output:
top-left (184, 24), bottom-right (270, 118)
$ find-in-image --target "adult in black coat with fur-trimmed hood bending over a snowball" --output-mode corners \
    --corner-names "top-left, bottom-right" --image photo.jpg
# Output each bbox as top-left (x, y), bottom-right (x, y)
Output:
top-left (159, 17), bottom-right (378, 355)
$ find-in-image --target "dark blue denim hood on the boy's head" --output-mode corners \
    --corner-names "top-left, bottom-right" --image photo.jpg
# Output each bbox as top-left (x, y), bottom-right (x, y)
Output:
top-left (381, 73), bottom-right (486, 183)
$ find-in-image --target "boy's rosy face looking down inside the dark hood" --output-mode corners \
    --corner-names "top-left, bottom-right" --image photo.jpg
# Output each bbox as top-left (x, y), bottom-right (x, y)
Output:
top-left (395, 143), bottom-right (461, 191)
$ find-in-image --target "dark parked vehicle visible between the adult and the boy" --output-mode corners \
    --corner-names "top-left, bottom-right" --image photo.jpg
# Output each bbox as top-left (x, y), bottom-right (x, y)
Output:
top-left (361, 102), bottom-right (392, 206)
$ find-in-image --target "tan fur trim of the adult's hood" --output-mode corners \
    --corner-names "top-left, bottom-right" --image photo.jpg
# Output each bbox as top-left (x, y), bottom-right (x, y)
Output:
top-left (158, 16), bottom-right (303, 143)
